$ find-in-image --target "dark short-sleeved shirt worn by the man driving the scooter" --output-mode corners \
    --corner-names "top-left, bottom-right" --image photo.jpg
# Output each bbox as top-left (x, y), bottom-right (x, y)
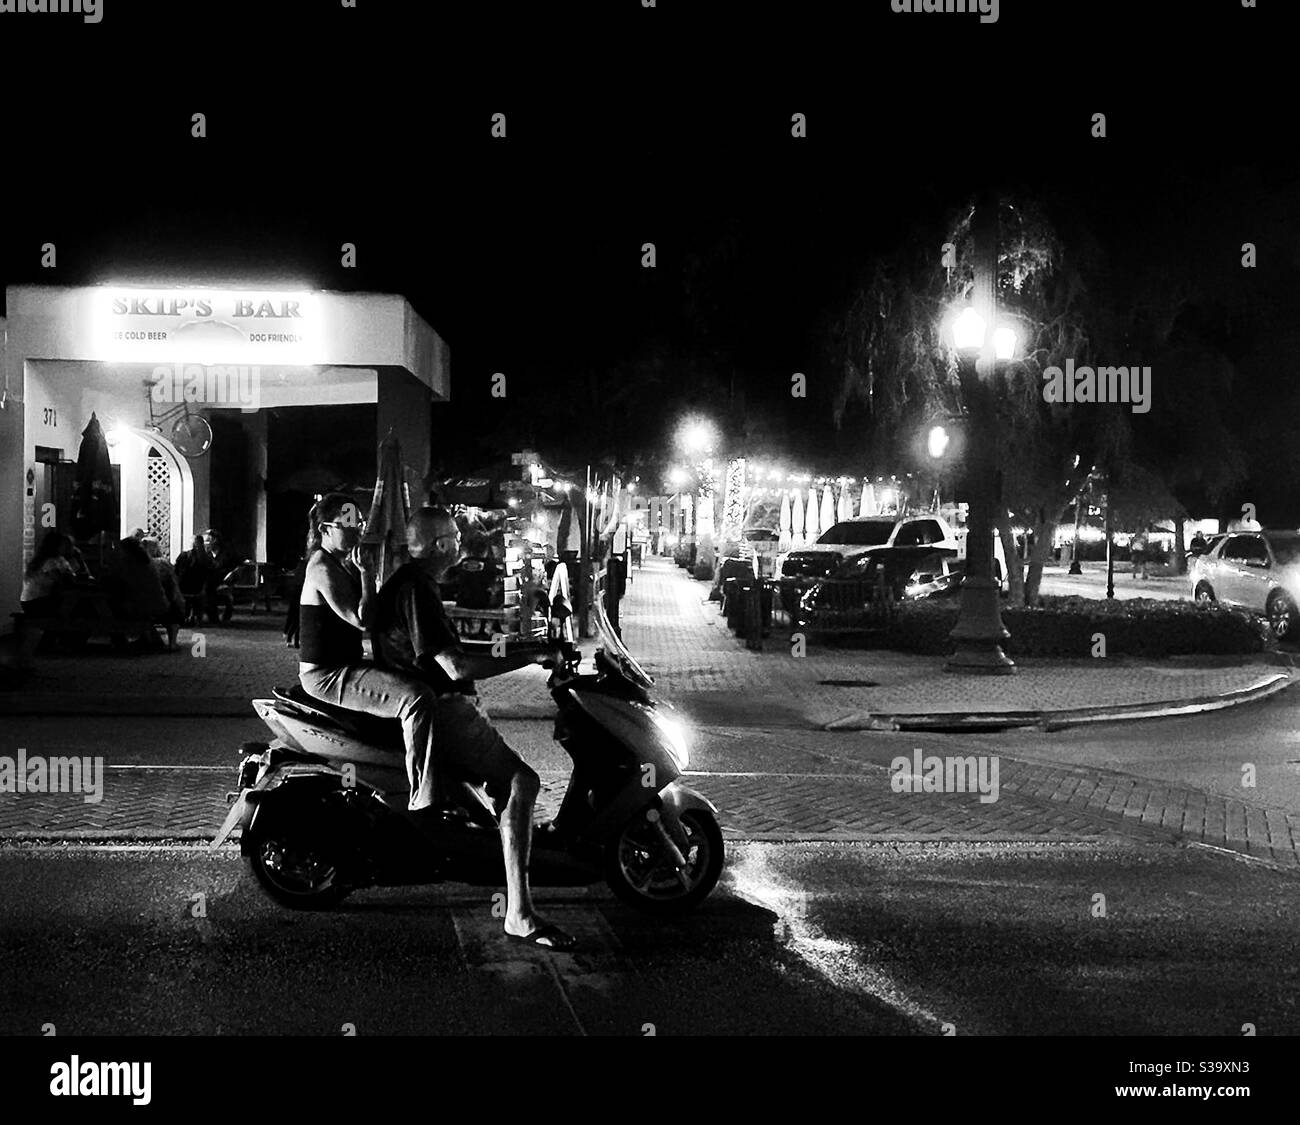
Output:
top-left (371, 563), bottom-right (475, 695)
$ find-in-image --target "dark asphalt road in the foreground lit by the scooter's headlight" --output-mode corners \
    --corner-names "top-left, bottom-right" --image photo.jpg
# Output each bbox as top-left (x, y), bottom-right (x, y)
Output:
top-left (0, 844), bottom-right (1300, 1035)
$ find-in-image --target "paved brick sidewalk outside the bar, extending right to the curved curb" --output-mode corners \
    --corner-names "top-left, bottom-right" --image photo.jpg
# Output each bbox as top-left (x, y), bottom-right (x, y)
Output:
top-left (0, 558), bottom-right (1283, 728)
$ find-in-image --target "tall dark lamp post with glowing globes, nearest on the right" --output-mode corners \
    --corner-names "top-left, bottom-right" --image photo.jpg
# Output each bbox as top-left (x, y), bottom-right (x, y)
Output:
top-left (944, 194), bottom-right (1015, 675)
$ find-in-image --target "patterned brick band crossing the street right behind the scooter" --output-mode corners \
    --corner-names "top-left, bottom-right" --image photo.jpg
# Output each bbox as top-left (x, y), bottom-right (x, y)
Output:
top-left (0, 757), bottom-right (1300, 870)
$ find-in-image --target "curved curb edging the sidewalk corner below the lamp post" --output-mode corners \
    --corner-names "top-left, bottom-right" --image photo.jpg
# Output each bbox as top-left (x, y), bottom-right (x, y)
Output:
top-left (822, 672), bottom-right (1292, 732)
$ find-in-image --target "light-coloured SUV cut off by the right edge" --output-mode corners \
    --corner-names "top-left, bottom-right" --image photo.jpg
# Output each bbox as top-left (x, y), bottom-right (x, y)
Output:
top-left (1188, 531), bottom-right (1300, 640)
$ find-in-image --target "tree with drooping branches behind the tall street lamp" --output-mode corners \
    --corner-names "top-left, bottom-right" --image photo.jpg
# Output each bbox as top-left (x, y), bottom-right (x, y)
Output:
top-left (824, 196), bottom-right (1221, 605)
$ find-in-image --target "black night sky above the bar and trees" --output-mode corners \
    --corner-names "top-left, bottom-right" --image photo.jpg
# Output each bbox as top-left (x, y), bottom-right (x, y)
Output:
top-left (0, 3), bottom-right (1300, 522)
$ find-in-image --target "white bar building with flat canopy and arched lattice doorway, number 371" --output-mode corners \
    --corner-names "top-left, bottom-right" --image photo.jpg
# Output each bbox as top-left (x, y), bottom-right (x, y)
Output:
top-left (0, 285), bottom-right (450, 619)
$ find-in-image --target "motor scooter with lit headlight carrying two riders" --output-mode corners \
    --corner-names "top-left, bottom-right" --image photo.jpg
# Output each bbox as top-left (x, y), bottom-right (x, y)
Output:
top-left (212, 598), bottom-right (724, 914)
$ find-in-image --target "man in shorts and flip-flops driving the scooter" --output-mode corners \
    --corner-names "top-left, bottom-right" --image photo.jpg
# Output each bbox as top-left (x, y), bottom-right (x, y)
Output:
top-left (371, 507), bottom-right (577, 951)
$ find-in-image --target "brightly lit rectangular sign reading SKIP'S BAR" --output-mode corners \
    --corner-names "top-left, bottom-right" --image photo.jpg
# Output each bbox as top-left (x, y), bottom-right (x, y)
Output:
top-left (94, 289), bottom-right (320, 364)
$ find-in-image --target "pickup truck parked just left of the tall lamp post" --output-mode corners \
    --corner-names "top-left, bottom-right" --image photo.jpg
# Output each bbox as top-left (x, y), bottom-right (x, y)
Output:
top-left (781, 515), bottom-right (1006, 596)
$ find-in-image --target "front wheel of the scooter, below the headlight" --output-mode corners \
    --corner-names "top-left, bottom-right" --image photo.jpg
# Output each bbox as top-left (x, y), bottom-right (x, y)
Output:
top-left (605, 809), bottom-right (724, 916)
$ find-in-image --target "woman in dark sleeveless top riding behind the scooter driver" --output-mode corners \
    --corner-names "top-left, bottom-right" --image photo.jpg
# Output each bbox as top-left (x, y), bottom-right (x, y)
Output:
top-left (298, 493), bottom-right (437, 810)
